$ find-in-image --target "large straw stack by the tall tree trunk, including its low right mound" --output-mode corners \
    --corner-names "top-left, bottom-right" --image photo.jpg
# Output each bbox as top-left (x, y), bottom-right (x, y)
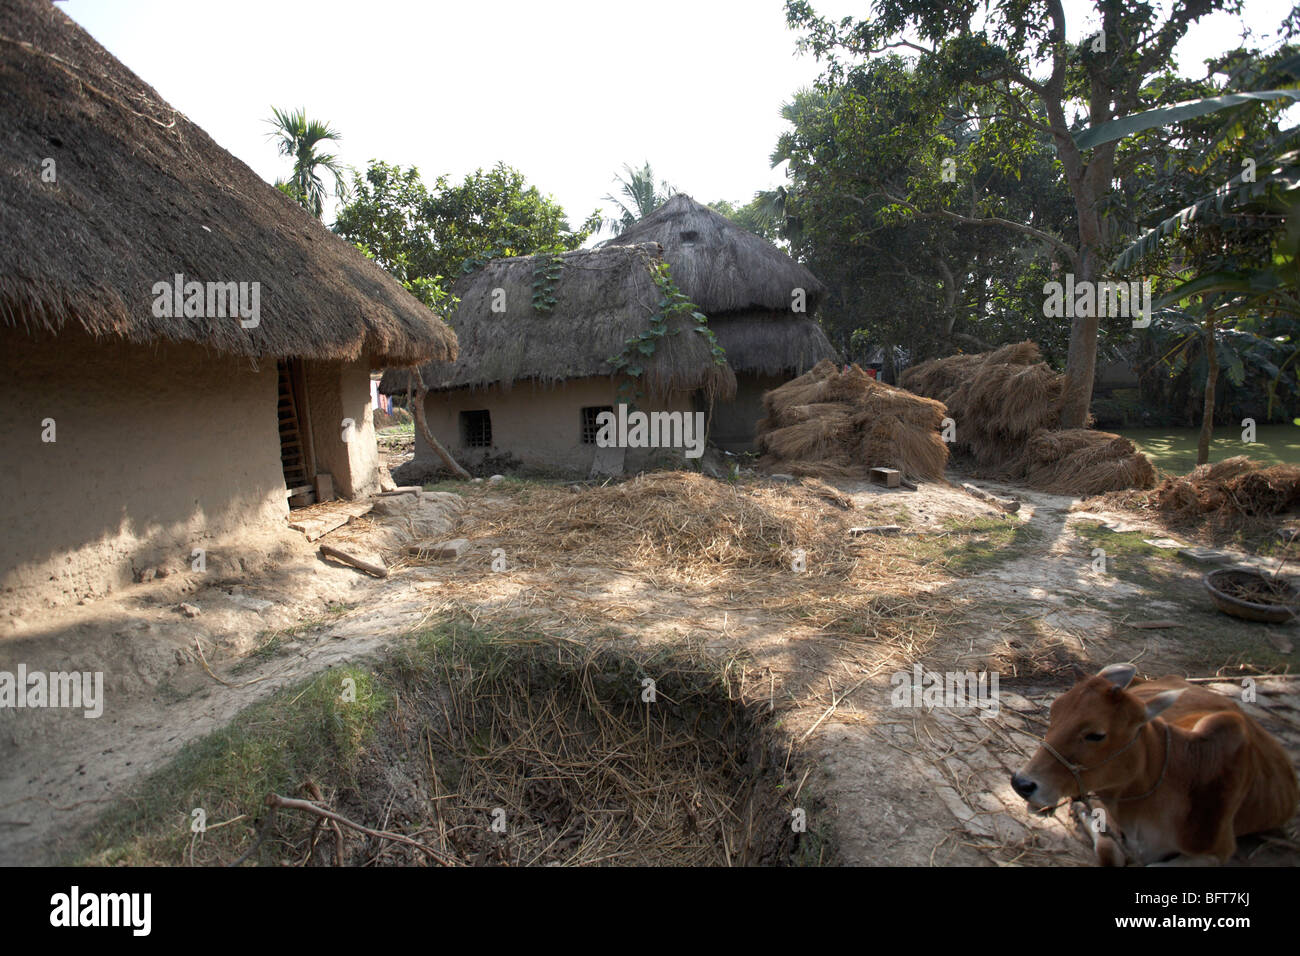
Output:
top-left (900, 342), bottom-right (1156, 494)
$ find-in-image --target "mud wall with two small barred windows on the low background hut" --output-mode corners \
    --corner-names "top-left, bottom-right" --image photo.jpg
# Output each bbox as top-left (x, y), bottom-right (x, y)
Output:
top-left (415, 376), bottom-right (694, 477)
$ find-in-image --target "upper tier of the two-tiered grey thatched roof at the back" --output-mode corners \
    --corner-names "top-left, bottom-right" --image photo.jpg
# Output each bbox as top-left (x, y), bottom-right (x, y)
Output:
top-left (605, 193), bottom-right (826, 317)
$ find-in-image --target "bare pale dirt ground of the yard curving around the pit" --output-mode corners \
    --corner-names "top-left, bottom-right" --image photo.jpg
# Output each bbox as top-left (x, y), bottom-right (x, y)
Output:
top-left (0, 447), bottom-right (1300, 865)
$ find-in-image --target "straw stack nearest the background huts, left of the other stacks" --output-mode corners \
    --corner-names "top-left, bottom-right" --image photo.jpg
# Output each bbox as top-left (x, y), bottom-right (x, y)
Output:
top-left (758, 362), bottom-right (948, 480)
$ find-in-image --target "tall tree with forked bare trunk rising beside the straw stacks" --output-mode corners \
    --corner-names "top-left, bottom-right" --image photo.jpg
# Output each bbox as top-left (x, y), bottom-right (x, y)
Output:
top-left (785, 0), bottom-right (1274, 427)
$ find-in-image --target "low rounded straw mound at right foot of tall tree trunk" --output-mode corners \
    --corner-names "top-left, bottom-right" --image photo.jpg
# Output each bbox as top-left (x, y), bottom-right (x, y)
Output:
top-left (1014, 428), bottom-right (1156, 496)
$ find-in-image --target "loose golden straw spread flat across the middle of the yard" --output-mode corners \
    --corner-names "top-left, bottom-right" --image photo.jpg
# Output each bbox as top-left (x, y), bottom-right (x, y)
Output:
top-left (404, 472), bottom-right (953, 642)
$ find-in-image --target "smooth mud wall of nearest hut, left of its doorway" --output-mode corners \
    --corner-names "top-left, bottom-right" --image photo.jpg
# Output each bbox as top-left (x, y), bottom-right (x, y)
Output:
top-left (0, 326), bottom-right (287, 614)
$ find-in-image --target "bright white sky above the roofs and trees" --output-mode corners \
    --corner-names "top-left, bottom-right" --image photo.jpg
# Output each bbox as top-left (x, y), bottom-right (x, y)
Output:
top-left (60, 0), bottom-right (1290, 236)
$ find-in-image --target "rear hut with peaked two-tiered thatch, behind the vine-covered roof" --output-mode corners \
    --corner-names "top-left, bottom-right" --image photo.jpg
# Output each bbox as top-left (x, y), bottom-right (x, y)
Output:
top-left (605, 193), bottom-right (835, 375)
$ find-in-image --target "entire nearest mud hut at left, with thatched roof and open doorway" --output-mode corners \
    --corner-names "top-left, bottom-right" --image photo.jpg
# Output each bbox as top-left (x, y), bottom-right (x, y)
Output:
top-left (0, 0), bottom-right (456, 613)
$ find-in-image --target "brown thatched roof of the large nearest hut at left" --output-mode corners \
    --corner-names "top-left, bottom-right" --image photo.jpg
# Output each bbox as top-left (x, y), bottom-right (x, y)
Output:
top-left (0, 0), bottom-right (456, 365)
